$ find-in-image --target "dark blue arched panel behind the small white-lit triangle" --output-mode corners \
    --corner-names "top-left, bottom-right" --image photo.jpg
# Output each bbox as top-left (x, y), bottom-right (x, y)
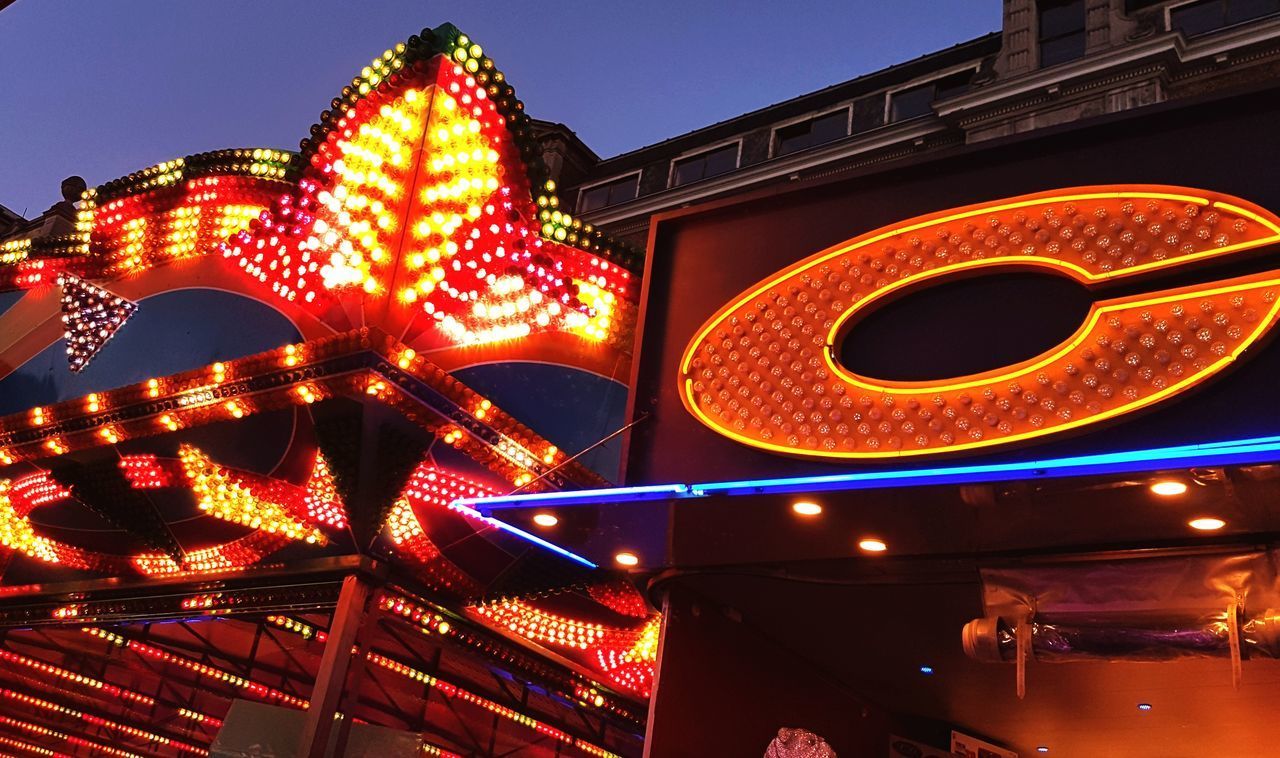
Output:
top-left (0, 289), bottom-right (298, 414)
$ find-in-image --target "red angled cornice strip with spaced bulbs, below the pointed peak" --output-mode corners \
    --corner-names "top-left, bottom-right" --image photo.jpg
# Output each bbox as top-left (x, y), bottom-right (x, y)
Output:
top-left (0, 329), bottom-right (603, 490)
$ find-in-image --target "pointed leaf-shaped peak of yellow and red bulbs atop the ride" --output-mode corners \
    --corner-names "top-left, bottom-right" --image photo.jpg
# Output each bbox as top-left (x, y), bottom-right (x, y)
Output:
top-left (223, 31), bottom-right (630, 344)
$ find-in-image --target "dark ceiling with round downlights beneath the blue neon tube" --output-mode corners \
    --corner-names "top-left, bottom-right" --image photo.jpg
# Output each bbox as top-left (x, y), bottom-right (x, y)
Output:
top-left (614, 458), bottom-right (1280, 758)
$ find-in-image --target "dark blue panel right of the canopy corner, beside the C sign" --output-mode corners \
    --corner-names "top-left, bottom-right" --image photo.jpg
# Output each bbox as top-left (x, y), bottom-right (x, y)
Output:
top-left (454, 362), bottom-right (627, 481)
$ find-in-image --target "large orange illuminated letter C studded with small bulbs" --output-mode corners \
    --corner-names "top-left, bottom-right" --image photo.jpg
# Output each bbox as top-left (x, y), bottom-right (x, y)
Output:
top-left (678, 187), bottom-right (1280, 458)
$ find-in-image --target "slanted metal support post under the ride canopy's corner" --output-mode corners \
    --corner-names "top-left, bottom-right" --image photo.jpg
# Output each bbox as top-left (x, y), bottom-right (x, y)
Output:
top-left (297, 575), bottom-right (372, 758)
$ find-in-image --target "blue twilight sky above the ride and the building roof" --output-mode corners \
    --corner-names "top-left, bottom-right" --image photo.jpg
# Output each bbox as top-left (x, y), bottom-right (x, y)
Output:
top-left (0, 0), bottom-right (1001, 212)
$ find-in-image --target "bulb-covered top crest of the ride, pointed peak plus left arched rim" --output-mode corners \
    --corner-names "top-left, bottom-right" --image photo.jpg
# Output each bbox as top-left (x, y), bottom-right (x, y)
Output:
top-left (0, 26), bottom-right (641, 344)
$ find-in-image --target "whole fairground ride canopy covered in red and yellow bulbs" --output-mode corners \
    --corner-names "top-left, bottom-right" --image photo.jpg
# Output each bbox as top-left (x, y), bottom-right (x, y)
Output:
top-left (0, 24), bottom-right (658, 754)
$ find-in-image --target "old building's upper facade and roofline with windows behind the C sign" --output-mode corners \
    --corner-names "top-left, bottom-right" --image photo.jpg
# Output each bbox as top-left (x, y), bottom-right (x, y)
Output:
top-left (543, 0), bottom-right (1280, 247)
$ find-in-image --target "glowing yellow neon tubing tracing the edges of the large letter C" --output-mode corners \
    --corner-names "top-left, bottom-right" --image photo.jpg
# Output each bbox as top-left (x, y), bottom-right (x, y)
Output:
top-left (680, 191), bottom-right (1280, 460)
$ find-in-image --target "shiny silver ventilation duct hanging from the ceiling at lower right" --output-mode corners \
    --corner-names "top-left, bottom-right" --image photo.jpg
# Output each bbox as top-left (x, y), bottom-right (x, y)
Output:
top-left (961, 549), bottom-right (1280, 697)
